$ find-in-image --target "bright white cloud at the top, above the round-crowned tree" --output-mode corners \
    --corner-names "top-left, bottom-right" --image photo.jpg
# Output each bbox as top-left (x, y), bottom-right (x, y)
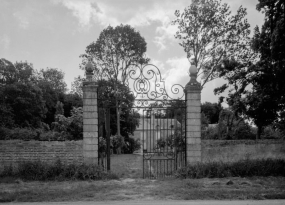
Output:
top-left (51, 0), bottom-right (183, 48)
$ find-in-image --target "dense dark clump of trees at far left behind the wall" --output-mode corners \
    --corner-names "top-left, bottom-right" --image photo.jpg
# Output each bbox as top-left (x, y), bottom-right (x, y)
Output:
top-left (0, 59), bottom-right (69, 127)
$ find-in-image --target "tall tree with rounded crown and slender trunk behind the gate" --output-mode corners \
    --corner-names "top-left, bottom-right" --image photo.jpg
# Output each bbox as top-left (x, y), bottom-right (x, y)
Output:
top-left (81, 24), bottom-right (149, 135)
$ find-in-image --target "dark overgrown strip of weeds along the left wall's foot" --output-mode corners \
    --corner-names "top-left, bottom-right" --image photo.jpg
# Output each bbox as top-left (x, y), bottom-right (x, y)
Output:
top-left (0, 160), bottom-right (118, 181)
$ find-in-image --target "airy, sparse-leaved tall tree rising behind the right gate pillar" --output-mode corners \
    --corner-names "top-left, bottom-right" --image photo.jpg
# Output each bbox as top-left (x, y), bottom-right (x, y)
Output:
top-left (173, 0), bottom-right (254, 86)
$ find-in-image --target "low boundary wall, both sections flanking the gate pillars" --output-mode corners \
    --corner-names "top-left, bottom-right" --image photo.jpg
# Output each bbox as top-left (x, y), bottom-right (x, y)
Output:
top-left (0, 140), bottom-right (285, 170)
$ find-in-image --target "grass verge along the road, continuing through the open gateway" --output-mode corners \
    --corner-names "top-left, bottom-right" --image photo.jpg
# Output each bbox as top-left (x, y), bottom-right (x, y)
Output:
top-left (0, 155), bottom-right (285, 202)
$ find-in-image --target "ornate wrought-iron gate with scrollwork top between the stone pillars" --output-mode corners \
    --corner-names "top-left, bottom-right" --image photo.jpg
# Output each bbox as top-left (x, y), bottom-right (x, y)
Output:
top-left (98, 64), bottom-right (186, 178)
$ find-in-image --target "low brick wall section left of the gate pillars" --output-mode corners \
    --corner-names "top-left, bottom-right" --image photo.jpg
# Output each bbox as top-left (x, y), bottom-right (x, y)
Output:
top-left (0, 140), bottom-right (83, 170)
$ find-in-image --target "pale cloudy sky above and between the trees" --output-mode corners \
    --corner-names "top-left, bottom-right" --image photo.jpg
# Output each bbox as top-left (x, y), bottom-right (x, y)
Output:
top-left (0, 0), bottom-right (264, 102)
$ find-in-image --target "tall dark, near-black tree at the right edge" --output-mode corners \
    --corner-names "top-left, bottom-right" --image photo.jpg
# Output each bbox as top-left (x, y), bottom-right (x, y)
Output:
top-left (215, 0), bottom-right (285, 139)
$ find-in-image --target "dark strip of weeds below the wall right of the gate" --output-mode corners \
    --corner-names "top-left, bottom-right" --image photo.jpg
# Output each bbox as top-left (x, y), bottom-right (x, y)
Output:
top-left (176, 159), bottom-right (285, 179)
